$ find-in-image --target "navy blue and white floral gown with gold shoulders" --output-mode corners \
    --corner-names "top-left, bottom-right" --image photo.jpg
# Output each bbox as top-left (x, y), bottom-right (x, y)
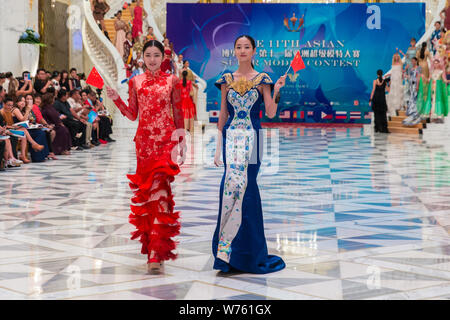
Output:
top-left (212, 72), bottom-right (285, 274)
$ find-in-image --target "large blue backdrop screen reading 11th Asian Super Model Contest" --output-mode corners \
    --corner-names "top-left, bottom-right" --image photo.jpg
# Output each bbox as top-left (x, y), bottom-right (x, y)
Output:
top-left (167, 3), bottom-right (425, 123)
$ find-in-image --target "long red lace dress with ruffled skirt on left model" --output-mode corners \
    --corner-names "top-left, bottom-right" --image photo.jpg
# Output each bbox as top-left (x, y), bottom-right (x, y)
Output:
top-left (114, 70), bottom-right (184, 262)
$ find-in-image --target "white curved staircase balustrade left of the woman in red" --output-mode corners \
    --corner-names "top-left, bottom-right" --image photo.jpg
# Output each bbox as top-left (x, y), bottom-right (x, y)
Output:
top-left (82, 0), bottom-right (134, 128)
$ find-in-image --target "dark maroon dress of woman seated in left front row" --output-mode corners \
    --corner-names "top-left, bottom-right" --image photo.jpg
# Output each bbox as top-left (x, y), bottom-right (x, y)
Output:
top-left (41, 93), bottom-right (72, 155)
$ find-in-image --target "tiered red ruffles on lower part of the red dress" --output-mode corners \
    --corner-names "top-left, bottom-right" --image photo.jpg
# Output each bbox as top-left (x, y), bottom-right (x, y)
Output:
top-left (127, 160), bottom-right (181, 261)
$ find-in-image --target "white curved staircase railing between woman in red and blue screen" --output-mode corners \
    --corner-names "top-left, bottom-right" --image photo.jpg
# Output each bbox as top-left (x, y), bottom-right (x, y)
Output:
top-left (143, 0), bottom-right (209, 122)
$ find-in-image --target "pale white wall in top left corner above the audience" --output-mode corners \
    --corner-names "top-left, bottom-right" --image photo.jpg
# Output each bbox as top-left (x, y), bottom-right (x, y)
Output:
top-left (0, 0), bottom-right (39, 76)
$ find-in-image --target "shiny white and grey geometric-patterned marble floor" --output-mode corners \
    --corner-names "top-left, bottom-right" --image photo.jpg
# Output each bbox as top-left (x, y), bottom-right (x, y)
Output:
top-left (0, 128), bottom-right (450, 300)
